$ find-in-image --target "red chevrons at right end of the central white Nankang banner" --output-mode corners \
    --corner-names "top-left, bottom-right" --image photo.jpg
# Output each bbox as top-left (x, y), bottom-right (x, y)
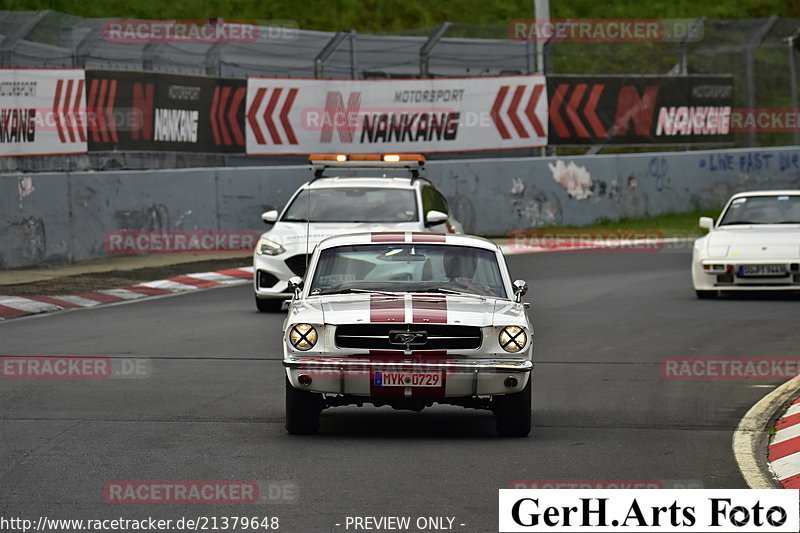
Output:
top-left (490, 84), bottom-right (545, 139)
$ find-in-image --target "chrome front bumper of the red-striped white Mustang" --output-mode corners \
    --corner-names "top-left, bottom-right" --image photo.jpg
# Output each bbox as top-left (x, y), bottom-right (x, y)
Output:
top-left (283, 357), bottom-right (533, 398)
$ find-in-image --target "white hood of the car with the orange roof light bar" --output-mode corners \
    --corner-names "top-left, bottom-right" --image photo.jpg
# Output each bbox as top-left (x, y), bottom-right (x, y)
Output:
top-left (261, 222), bottom-right (420, 253)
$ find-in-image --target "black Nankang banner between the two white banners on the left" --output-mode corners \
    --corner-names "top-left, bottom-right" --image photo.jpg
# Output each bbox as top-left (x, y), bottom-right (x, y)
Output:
top-left (86, 70), bottom-right (247, 153)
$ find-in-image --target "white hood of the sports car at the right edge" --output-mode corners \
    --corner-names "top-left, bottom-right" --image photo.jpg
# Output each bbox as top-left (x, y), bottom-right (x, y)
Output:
top-left (707, 225), bottom-right (800, 259)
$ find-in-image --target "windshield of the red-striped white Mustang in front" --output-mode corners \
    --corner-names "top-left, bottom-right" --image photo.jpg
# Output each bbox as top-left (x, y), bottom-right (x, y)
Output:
top-left (310, 243), bottom-right (507, 298)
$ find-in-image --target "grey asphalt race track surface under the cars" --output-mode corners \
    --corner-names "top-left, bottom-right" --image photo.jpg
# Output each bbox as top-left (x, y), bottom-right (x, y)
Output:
top-left (0, 244), bottom-right (798, 532)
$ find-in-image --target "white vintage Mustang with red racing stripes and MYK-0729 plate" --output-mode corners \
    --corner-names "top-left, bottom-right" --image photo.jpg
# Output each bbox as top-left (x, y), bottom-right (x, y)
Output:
top-left (283, 232), bottom-right (533, 436)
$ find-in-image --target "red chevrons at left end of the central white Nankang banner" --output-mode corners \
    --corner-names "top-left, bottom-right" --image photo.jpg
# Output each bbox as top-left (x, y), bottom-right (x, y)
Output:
top-left (247, 87), bottom-right (298, 144)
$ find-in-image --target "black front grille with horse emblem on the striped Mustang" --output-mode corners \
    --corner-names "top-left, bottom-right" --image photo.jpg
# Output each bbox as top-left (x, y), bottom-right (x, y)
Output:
top-left (335, 324), bottom-right (482, 350)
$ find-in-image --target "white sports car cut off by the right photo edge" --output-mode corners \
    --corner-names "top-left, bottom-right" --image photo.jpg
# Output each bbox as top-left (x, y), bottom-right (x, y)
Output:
top-left (692, 191), bottom-right (800, 298)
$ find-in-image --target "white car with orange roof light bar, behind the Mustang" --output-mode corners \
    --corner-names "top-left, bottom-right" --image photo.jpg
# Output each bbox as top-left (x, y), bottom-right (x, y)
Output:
top-left (253, 154), bottom-right (463, 311)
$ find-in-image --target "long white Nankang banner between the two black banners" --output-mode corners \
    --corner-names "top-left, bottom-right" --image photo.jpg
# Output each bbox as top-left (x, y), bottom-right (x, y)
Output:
top-left (246, 75), bottom-right (547, 155)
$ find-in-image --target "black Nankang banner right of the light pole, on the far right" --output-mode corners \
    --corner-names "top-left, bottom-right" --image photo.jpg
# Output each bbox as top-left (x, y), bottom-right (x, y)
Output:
top-left (547, 75), bottom-right (734, 145)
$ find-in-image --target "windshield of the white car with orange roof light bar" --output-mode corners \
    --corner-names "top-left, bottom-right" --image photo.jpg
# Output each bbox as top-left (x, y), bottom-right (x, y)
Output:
top-left (282, 187), bottom-right (417, 223)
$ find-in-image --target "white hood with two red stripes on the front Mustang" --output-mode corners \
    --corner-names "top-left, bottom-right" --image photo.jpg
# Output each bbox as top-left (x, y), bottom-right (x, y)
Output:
top-left (287, 293), bottom-right (529, 327)
